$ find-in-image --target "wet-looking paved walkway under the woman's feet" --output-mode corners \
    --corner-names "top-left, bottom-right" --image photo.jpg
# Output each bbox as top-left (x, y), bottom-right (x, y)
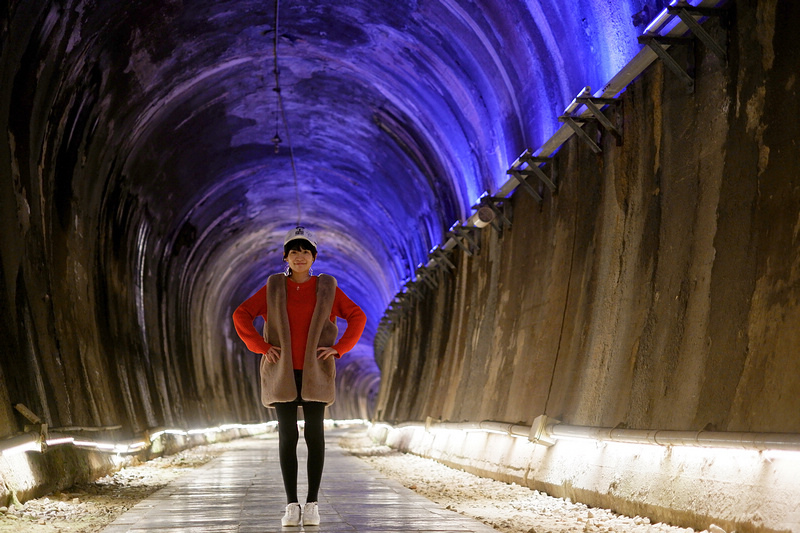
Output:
top-left (103, 432), bottom-right (496, 533)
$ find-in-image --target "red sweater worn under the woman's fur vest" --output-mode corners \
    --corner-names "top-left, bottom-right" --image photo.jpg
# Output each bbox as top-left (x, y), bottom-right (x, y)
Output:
top-left (233, 276), bottom-right (367, 370)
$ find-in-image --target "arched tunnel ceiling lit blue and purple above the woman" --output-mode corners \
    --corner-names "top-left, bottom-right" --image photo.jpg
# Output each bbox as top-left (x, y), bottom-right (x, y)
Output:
top-left (4, 0), bottom-right (648, 354)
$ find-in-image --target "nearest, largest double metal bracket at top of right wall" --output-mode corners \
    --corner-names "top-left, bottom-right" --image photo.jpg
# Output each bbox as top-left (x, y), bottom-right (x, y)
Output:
top-left (639, 0), bottom-right (728, 92)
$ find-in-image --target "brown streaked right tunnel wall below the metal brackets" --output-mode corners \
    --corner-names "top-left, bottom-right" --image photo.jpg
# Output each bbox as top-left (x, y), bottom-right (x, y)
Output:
top-left (377, 2), bottom-right (800, 432)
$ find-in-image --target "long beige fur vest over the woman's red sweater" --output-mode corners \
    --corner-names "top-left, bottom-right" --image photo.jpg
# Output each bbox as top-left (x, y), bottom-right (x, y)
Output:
top-left (261, 274), bottom-right (338, 407)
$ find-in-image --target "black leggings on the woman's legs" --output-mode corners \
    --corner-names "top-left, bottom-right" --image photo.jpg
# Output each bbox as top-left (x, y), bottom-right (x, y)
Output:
top-left (273, 371), bottom-right (325, 503)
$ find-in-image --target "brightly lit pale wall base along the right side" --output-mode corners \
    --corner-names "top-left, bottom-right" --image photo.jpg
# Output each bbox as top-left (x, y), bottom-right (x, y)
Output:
top-left (369, 425), bottom-right (800, 531)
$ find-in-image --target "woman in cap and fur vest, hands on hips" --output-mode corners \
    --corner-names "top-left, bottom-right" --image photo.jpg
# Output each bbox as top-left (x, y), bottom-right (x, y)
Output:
top-left (233, 226), bottom-right (367, 526)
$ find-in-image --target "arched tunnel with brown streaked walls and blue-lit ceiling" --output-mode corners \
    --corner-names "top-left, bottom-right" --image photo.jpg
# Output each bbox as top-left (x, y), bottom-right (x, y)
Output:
top-left (0, 0), bottom-right (800, 531)
